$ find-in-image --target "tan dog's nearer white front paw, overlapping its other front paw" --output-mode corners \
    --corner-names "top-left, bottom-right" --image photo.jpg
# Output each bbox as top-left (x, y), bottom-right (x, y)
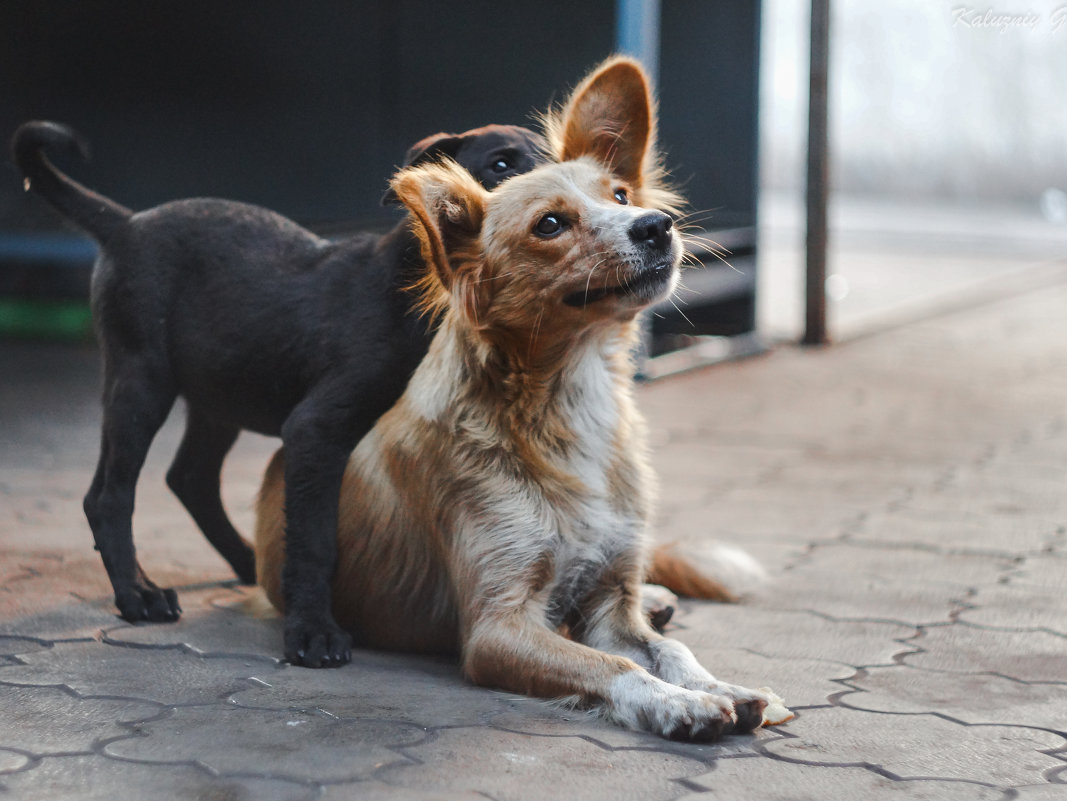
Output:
top-left (609, 670), bottom-right (737, 742)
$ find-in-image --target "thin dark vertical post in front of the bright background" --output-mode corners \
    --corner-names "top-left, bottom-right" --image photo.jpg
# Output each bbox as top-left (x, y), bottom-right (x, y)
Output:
top-left (801, 0), bottom-right (830, 345)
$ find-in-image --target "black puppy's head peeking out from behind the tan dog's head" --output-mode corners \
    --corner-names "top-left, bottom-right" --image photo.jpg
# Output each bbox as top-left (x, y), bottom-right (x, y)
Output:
top-left (382, 125), bottom-right (547, 205)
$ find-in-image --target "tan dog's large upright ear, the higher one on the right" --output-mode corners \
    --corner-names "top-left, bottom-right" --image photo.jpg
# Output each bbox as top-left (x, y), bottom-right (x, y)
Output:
top-left (548, 57), bottom-right (655, 188)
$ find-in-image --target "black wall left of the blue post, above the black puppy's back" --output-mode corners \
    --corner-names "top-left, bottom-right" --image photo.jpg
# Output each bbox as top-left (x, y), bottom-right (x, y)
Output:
top-left (0, 0), bottom-right (612, 228)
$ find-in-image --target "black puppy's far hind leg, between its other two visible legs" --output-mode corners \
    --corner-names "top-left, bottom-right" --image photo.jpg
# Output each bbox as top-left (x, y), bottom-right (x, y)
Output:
top-left (166, 406), bottom-right (256, 584)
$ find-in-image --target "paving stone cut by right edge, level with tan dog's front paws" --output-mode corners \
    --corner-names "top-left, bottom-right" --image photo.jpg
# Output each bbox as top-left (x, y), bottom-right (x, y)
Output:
top-left (838, 666), bottom-right (1067, 731)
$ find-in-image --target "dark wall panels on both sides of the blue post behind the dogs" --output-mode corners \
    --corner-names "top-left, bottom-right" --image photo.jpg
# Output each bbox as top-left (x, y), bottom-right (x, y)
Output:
top-left (0, 0), bottom-right (759, 327)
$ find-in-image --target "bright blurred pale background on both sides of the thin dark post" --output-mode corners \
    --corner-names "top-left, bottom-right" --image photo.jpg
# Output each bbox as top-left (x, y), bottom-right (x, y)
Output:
top-left (759, 0), bottom-right (1067, 339)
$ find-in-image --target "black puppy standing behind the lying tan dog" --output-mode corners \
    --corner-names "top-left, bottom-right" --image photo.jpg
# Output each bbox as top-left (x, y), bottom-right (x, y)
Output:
top-left (12, 122), bottom-right (542, 667)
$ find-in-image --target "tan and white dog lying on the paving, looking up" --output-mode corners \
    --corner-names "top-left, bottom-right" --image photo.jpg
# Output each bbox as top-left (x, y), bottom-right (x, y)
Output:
top-left (256, 58), bottom-right (767, 740)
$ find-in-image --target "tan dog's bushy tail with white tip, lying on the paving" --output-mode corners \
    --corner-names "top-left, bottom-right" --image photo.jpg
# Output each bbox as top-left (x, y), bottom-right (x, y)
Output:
top-left (646, 542), bottom-right (766, 603)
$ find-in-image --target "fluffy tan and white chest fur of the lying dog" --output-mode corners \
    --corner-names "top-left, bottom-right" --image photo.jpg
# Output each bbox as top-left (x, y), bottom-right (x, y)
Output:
top-left (386, 321), bottom-right (651, 623)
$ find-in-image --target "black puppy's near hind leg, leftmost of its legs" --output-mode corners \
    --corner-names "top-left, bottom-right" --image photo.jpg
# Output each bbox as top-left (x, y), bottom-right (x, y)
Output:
top-left (83, 362), bottom-right (181, 622)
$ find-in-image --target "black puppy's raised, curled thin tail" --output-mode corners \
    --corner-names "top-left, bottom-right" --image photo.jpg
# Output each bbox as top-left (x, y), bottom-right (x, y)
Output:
top-left (11, 122), bottom-right (133, 243)
